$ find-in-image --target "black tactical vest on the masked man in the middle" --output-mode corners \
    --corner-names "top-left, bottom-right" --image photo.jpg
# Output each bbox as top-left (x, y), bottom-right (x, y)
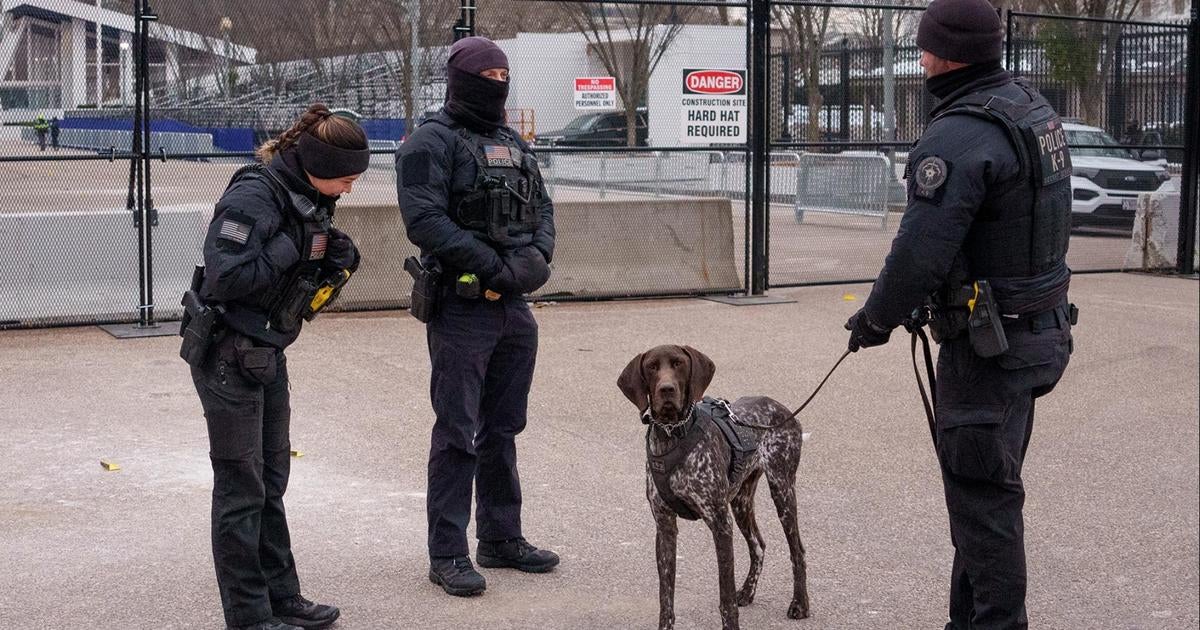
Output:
top-left (426, 118), bottom-right (546, 246)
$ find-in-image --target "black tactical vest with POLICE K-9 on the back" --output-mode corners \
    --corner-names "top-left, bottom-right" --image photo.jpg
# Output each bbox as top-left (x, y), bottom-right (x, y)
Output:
top-left (934, 79), bottom-right (1072, 278)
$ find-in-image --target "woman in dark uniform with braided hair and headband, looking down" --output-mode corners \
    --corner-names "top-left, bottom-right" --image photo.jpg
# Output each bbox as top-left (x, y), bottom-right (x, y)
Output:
top-left (185, 103), bottom-right (370, 630)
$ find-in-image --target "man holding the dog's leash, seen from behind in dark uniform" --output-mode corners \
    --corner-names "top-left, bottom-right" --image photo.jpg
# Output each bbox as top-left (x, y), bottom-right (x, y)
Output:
top-left (846, 0), bottom-right (1074, 630)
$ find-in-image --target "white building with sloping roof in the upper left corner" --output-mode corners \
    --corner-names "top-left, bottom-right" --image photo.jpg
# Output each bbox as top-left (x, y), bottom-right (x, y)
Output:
top-left (0, 0), bottom-right (257, 118)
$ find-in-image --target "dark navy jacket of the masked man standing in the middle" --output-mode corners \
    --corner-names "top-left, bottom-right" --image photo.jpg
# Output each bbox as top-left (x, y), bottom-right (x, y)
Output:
top-left (396, 110), bottom-right (554, 293)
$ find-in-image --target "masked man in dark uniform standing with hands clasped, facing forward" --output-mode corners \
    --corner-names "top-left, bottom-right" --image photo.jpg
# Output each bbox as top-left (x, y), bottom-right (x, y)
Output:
top-left (396, 37), bottom-right (558, 596)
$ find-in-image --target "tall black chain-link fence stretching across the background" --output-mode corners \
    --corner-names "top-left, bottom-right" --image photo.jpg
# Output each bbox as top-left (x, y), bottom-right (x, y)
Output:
top-left (0, 0), bottom-right (1189, 328)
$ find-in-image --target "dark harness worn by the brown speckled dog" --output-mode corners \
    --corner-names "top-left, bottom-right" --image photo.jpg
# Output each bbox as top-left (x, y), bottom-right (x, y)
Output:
top-left (646, 396), bottom-right (758, 521)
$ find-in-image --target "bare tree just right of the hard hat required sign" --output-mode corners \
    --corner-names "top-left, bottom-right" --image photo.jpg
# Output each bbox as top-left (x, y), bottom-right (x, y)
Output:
top-left (772, 6), bottom-right (830, 142)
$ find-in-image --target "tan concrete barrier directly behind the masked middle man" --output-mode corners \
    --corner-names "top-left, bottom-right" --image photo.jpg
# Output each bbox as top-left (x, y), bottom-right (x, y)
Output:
top-left (337, 199), bottom-right (740, 304)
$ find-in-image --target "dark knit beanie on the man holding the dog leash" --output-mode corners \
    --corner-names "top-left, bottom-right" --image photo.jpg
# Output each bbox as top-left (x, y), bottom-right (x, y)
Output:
top-left (917, 0), bottom-right (1004, 64)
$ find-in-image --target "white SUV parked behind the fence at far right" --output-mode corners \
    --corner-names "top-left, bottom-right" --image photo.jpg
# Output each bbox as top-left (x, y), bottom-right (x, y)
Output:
top-left (1062, 122), bottom-right (1172, 227)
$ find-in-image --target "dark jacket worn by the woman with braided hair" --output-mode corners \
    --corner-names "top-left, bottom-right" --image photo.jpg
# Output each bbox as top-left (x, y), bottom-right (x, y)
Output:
top-left (200, 150), bottom-right (350, 348)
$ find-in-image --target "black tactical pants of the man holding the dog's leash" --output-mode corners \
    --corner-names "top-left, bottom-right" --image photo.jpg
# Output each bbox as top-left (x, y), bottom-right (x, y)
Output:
top-left (936, 310), bottom-right (1072, 630)
